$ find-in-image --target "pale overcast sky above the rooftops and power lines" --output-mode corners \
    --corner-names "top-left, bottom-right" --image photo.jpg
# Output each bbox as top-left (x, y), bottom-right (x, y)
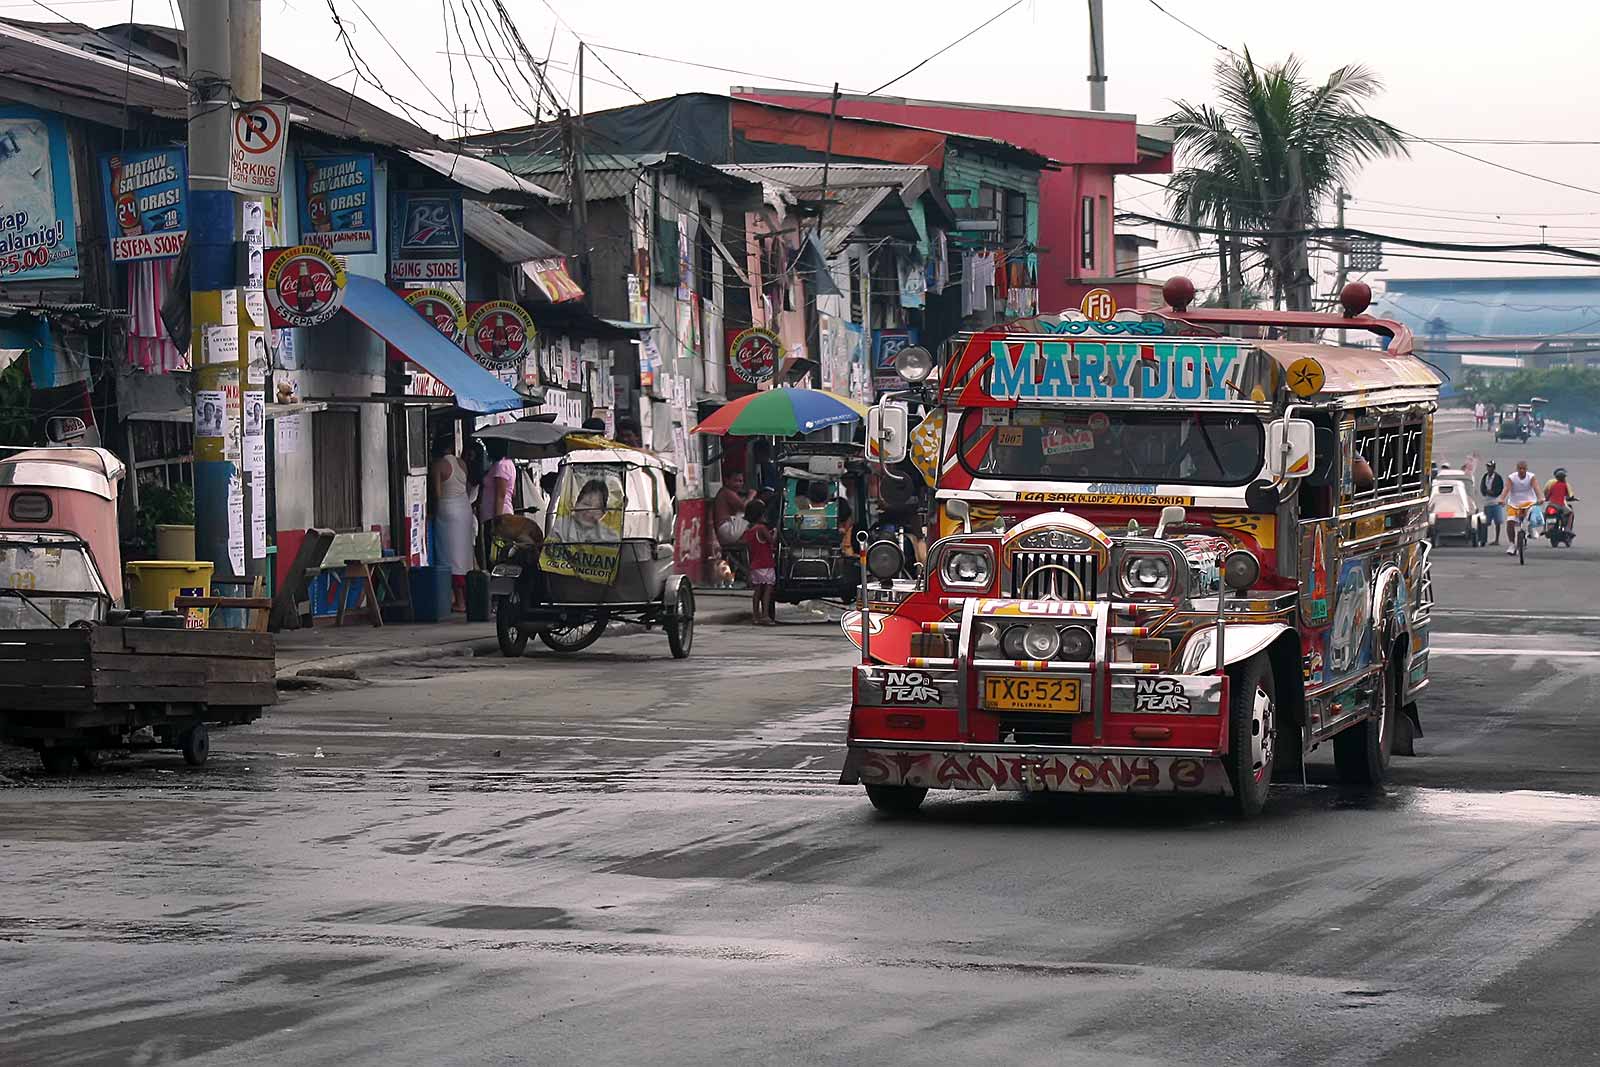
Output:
top-left (21, 0), bottom-right (1600, 283)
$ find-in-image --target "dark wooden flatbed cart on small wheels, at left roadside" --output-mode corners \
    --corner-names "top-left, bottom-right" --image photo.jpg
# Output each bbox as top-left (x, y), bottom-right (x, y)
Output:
top-left (0, 625), bottom-right (277, 773)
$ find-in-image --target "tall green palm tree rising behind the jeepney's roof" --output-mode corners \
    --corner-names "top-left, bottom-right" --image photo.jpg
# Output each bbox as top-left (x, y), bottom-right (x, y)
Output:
top-left (1162, 48), bottom-right (1408, 310)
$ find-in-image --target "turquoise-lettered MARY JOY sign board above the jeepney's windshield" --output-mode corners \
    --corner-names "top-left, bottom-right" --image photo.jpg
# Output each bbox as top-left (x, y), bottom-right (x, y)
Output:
top-left (989, 341), bottom-right (1248, 400)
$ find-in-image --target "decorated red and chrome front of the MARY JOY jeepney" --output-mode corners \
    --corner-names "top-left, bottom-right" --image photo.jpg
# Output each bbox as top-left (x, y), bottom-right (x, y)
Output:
top-left (845, 295), bottom-right (1312, 806)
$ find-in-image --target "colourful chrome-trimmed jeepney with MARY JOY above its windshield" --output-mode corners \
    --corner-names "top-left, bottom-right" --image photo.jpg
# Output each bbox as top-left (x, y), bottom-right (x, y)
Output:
top-left (842, 278), bottom-right (1440, 814)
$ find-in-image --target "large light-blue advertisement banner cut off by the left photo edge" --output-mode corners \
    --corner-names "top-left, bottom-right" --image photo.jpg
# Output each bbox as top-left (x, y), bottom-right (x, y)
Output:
top-left (0, 107), bottom-right (78, 282)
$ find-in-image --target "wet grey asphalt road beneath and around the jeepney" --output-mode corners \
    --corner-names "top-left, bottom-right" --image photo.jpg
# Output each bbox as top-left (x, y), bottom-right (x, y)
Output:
top-left (0, 412), bottom-right (1600, 1065)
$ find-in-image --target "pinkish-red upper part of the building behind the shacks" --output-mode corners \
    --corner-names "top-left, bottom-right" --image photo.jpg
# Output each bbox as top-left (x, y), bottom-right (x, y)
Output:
top-left (733, 88), bottom-right (1173, 310)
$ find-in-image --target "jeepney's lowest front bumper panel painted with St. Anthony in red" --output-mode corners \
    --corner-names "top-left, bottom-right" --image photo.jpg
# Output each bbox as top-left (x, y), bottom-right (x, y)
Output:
top-left (838, 741), bottom-right (1234, 797)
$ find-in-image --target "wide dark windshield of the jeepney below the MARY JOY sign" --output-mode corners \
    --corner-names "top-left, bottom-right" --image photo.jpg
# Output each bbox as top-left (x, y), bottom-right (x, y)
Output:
top-left (960, 408), bottom-right (1266, 486)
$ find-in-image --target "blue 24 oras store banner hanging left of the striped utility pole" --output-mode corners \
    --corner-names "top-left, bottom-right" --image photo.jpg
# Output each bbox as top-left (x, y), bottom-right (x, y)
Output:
top-left (99, 147), bottom-right (189, 262)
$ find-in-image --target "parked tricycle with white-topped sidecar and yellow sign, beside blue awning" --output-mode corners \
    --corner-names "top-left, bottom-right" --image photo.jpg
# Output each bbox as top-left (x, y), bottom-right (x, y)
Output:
top-left (478, 421), bottom-right (694, 659)
